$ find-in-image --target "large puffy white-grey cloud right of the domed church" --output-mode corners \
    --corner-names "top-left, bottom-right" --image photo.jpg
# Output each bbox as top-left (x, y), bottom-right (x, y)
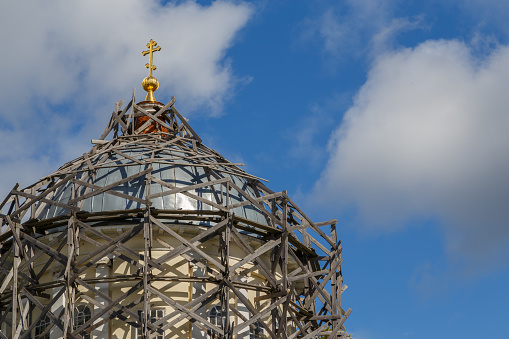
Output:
top-left (315, 41), bottom-right (509, 269)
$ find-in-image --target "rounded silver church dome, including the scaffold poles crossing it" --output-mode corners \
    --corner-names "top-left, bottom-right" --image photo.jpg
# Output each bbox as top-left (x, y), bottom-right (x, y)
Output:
top-left (36, 103), bottom-right (267, 225)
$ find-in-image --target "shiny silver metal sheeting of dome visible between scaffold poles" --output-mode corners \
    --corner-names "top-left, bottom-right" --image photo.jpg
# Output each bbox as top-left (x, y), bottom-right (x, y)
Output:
top-left (37, 143), bottom-right (266, 224)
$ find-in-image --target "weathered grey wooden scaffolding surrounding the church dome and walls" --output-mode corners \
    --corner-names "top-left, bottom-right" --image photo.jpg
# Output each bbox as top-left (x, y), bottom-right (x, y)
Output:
top-left (0, 97), bottom-right (351, 339)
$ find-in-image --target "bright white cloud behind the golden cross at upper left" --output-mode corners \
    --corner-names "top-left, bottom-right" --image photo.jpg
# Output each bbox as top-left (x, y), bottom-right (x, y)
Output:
top-left (0, 0), bottom-right (252, 114)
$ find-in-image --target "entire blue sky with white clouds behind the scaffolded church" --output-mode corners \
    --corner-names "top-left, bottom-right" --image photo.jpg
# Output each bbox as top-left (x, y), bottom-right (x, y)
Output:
top-left (0, 0), bottom-right (509, 339)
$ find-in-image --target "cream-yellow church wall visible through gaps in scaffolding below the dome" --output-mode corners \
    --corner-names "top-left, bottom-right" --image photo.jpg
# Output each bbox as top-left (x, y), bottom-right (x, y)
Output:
top-left (20, 226), bottom-right (293, 339)
